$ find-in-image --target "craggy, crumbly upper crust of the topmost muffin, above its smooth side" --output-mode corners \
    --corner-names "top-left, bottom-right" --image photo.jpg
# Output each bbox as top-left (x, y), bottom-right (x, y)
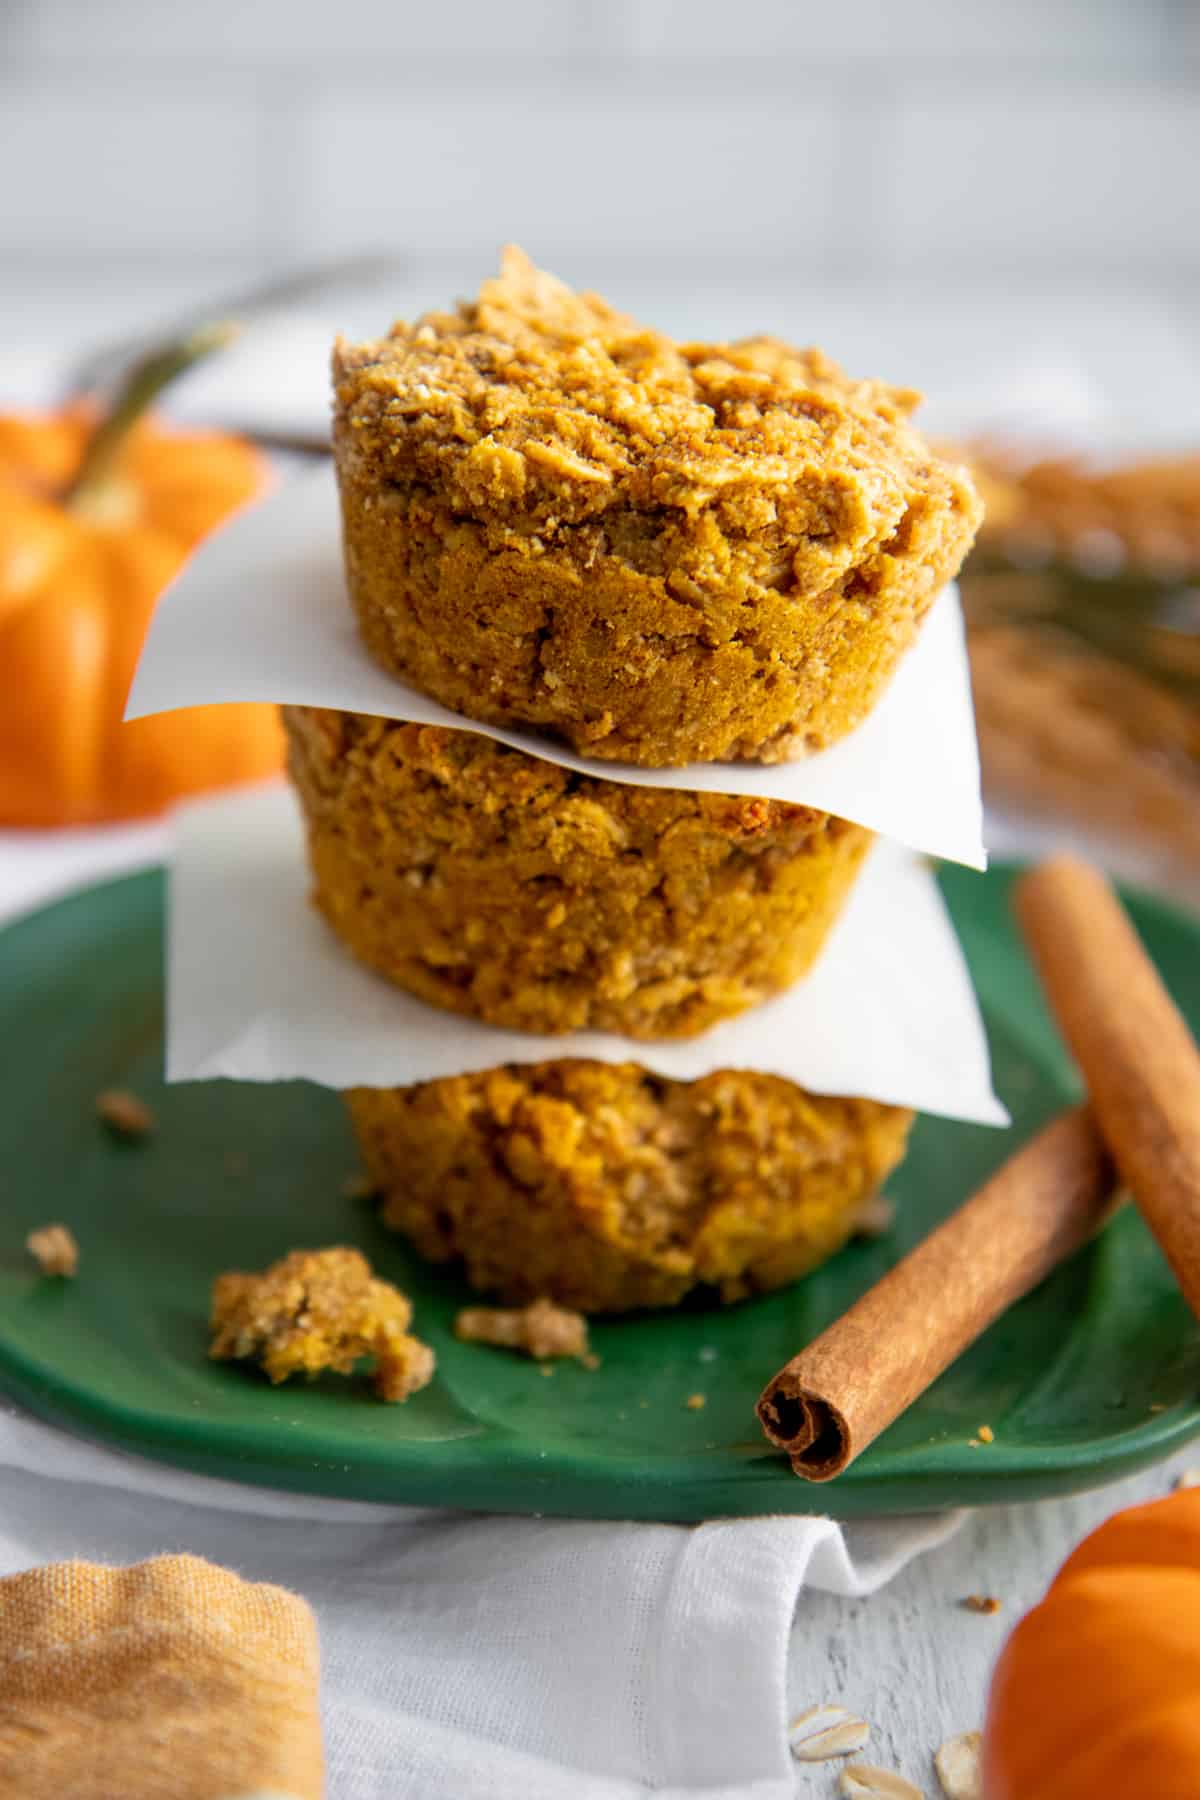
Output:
top-left (333, 248), bottom-right (977, 581)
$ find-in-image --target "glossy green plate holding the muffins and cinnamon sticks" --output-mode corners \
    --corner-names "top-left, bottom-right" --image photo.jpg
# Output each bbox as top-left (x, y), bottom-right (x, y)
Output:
top-left (0, 869), bottom-right (1200, 1519)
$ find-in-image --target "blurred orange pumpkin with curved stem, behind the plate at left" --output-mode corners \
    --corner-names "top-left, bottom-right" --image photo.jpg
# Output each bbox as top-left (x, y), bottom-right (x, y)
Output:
top-left (0, 328), bottom-right (282, 826)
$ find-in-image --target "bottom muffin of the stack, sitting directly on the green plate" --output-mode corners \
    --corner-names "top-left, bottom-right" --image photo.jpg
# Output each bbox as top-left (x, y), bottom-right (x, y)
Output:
top-left (347, 1060), bottom-right (912, 1312)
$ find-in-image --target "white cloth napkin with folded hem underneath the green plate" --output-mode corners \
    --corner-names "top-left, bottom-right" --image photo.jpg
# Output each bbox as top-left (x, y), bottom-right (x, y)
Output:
top-left (0, 1413), bottom-right (961, 1800)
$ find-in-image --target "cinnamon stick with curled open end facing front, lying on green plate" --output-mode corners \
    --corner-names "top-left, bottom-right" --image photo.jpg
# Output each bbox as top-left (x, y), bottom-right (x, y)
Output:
top-left (757, 1107), bottom-right (1115, 1481)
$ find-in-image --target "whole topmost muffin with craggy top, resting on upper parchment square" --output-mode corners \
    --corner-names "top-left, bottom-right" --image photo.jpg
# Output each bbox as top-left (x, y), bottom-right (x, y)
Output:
top-left (335, 250), bottom-right (981, 767)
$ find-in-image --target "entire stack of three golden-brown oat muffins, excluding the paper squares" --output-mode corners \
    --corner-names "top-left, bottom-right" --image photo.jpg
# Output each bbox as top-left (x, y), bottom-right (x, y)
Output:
top-left (284, 250), bottom-right (981, 1312)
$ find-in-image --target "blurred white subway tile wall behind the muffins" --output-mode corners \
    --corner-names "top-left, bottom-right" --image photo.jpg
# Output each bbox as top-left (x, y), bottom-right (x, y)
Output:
top-left (0, 0), bottom-right (1200, 428)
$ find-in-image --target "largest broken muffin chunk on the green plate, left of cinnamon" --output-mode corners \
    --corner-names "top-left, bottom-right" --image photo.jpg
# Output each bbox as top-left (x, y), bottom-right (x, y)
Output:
top-left (209, 1247), bottom-right (435, 1400)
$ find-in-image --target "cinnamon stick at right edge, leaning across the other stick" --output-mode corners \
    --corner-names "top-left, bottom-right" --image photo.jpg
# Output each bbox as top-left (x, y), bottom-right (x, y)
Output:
top-left (1015, 857), bottom-right (1200, 1318)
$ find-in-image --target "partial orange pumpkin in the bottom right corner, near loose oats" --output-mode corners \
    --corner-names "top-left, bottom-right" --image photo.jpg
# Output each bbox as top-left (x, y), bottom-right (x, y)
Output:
top-left (984, 1489), bottom-right (1200, 1800)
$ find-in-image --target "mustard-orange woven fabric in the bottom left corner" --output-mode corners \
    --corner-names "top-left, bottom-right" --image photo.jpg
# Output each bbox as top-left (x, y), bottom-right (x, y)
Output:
top-left (0, 1557), bottom-right (324, 1800)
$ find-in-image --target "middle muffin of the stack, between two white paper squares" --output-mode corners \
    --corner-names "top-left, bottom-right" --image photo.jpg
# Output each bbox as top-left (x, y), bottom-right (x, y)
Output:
top-left (284, 706), bottom-right (871, 1039)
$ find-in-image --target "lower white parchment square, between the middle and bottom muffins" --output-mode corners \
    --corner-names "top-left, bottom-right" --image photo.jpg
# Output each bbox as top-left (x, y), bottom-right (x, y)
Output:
top-left (167, 785), bottom-right (1007, 1125)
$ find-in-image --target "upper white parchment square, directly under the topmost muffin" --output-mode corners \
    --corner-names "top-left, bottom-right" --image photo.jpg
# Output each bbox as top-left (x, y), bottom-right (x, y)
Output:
top-left (126, 468), bottom-right (986, 869)
